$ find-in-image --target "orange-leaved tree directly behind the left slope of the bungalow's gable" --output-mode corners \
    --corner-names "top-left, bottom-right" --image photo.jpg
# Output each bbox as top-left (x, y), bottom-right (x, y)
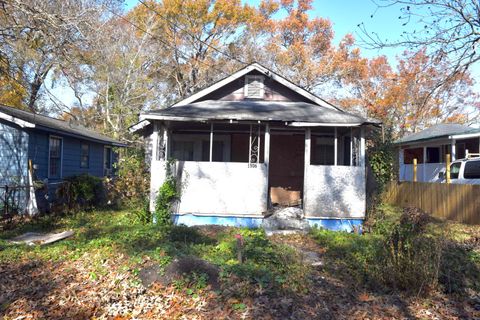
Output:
top-left (128, 0), bottom-right (259, 103)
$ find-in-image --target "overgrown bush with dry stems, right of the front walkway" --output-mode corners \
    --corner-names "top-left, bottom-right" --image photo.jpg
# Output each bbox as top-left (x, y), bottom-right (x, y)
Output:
top-left (312, 208), bottom-right (445, 294)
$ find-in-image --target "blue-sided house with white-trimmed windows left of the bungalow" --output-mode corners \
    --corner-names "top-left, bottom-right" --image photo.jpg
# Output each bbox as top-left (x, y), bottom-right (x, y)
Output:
top-left (0, 105), bottom-right (125, 213)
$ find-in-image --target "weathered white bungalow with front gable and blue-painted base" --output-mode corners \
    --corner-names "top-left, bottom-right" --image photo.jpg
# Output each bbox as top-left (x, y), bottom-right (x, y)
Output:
top-left (131, 63), bottom-right (375, 229)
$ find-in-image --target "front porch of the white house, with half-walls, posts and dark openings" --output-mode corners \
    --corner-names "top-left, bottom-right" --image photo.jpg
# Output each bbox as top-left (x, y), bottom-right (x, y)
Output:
top-left (150, 121), bottom-right (365, 229)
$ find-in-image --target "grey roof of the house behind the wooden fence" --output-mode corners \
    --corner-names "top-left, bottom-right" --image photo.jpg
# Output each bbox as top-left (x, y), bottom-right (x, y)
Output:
top-left (395, 123), bottom-right (480, 144)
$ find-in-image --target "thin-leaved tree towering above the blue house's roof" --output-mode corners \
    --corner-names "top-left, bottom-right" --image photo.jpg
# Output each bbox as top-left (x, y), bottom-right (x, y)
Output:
top-left (0, 0), bottom-right (119, 112)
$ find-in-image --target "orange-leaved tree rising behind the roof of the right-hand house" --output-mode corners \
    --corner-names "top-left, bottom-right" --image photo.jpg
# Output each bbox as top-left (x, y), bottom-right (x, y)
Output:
top-left (340, 50), bottom-right (479, 137)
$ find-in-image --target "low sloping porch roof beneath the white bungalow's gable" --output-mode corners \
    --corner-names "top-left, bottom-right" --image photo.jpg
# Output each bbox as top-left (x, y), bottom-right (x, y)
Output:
top-left (140, 100), bottom-right (376, 125)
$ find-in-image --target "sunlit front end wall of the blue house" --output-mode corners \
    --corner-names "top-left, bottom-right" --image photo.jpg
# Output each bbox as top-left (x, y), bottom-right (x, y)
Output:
top-left (0, 120), bottom-right (28, 211)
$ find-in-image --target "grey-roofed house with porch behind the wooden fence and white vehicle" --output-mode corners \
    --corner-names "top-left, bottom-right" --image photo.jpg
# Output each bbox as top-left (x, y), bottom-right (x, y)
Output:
top-left (395, 123), bottom-right (480, 182)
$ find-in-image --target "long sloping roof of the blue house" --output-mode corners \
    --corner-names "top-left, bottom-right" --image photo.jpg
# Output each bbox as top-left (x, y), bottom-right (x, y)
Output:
top-left (0, 105), bottom-right (126, 147)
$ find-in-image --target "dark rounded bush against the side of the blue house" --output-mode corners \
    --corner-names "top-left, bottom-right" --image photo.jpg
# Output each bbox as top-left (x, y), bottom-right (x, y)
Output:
top-left (55, 174), bottom-right (106, 211)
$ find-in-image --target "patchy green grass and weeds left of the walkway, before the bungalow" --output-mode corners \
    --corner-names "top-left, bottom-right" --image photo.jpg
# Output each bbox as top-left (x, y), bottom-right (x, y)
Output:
top-left (0, 210), bottom-right (307, 292)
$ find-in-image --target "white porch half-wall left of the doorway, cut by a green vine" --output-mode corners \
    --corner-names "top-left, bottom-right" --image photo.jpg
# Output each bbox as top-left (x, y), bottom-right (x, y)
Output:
top-left (151, 161), bottom-right (267, 216)
